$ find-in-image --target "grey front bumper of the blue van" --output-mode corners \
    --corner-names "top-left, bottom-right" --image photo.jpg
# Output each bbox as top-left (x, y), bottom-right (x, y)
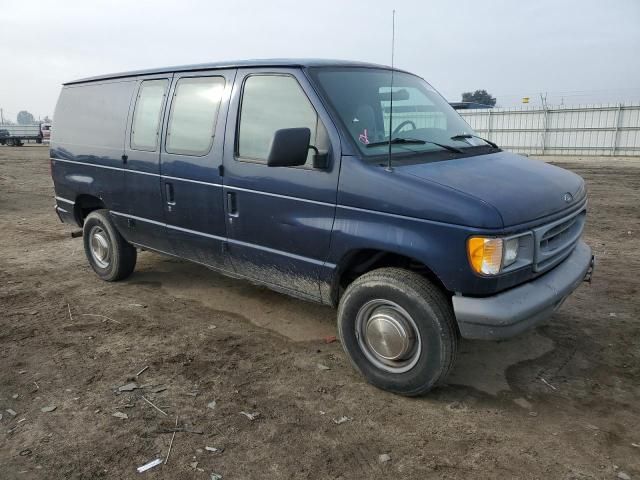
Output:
top-left (453, 240), bottom-right (593, 340)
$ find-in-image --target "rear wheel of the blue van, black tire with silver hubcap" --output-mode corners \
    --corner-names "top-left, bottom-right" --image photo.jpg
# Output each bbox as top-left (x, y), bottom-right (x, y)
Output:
top-left (82, 210), bottom-right (137, 282)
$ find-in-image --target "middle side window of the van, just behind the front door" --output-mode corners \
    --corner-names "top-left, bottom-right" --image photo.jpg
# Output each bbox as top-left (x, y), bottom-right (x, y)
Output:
top-left (166, 77), bottom-right (225, 156)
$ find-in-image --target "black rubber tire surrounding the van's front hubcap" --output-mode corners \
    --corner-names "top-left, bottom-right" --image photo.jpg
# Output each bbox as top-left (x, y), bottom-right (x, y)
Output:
top-left (338, 268), bottom-right (459, 396)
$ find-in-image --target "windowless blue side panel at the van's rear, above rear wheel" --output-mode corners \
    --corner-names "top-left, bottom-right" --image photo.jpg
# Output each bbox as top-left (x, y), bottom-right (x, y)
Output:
top-left (50, 79), bottom-right (136, 216)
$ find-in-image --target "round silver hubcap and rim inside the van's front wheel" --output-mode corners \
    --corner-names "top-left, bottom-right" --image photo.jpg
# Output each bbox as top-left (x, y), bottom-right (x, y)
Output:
top-left (356, 299), bottom-right (422, 373)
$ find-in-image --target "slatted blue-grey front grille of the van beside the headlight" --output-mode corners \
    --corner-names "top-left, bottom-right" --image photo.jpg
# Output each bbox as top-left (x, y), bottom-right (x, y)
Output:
top-left (533, 209), bottom-right (587, 272)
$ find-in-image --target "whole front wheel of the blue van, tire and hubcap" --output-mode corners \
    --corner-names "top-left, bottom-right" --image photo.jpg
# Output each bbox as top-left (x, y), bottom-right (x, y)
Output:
top-left (338, 268), bottom-right (458, 396)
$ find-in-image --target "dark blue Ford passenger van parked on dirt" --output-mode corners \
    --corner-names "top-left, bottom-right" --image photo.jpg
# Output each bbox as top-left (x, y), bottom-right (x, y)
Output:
top-left (50, 60), bottom-right (593, 395)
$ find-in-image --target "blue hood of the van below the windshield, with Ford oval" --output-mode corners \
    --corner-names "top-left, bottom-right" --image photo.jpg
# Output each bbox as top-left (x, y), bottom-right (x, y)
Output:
top-left (395, 152), bottom-right (586, 227)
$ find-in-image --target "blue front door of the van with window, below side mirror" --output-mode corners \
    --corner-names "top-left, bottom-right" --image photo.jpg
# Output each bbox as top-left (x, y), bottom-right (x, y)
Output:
top-left (224, 69), bottom-right (340, 300)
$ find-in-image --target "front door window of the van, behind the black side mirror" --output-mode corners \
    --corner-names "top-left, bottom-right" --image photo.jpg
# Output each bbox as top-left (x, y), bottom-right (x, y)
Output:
top-left (237, 75), bottom-right (329, 164)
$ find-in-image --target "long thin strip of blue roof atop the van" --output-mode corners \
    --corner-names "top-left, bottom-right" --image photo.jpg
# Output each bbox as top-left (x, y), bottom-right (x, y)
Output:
top-left (64, 58), bottom-right (402, 85)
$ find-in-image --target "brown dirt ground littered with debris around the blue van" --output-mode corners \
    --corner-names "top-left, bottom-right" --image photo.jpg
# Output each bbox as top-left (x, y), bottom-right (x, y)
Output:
top-left (0, 146), bottom-right (640, 480)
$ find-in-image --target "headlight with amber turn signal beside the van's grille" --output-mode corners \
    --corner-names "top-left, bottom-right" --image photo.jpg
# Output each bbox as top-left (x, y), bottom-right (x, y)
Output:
top-left (467, 233), bottom-right (533, 275)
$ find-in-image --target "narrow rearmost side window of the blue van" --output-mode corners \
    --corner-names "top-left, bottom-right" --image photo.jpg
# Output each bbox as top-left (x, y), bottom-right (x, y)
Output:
top-left (131, 80), bottom-right (169, 152)
